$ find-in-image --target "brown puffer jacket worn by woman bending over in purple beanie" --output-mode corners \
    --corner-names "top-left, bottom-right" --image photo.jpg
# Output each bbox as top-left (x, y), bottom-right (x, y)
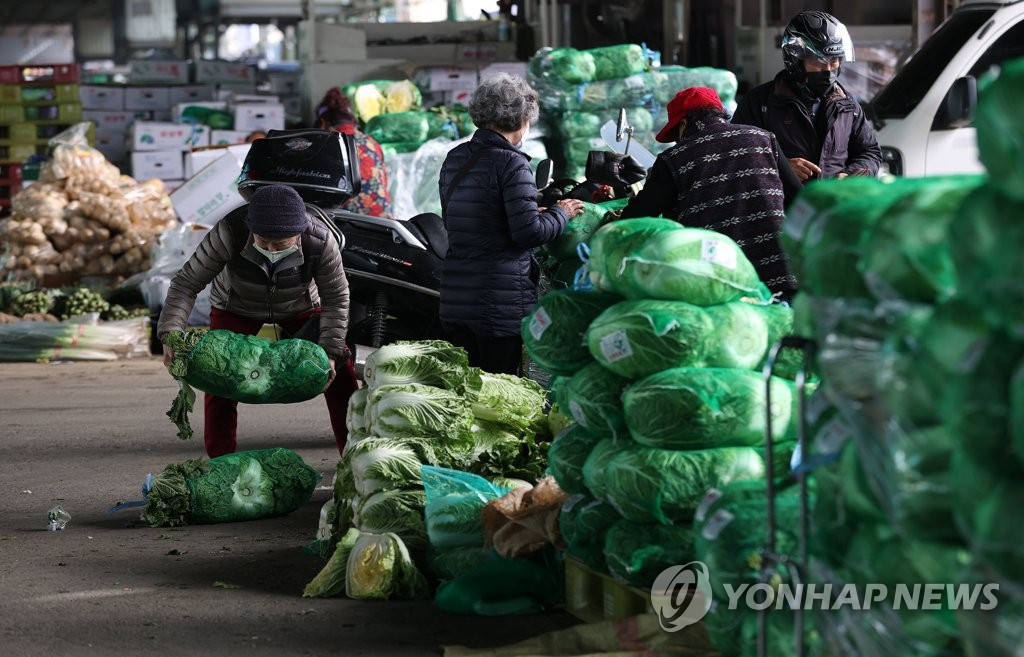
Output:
top-left (157, 206), bottom-right (348, 358)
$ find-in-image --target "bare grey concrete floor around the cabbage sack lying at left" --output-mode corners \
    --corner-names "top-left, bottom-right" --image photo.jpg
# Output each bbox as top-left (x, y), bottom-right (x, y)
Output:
top-left (0, 358), bottom-right (574, 657)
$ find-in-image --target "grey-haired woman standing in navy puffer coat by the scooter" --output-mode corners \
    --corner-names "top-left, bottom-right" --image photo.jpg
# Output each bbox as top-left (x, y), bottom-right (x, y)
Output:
top-left (438, 74), bottom-right (583, 375)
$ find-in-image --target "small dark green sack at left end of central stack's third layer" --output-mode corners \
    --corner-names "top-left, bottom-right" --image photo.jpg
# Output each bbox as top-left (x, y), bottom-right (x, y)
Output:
top-left (557, 362), bottom-right (629, 439)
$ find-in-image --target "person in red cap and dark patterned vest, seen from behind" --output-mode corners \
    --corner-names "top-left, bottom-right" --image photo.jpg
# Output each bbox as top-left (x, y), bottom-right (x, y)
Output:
top-left (621, 87), bottom-right (801, 301)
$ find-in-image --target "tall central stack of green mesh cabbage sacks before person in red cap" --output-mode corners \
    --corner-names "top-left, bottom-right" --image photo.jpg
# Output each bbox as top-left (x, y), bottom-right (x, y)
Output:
top-left (523, 213), bottom-right (811, 646)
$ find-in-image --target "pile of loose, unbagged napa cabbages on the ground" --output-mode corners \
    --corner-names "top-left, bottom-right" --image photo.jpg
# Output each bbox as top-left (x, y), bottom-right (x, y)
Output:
top-left (304, 341), bottom-right (550, 599)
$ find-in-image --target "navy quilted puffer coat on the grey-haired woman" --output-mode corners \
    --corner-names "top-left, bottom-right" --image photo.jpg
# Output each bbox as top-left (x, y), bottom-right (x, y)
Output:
top-left (438, 129), bottom-right (568, 337)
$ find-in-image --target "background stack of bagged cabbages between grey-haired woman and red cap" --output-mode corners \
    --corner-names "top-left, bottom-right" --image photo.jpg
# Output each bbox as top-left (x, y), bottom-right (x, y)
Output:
top-left (528, 44), bottom-right (736, 178)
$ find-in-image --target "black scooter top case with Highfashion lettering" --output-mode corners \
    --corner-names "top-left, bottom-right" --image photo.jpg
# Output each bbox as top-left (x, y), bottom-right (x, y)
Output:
top-left (239, 130), bottom-right (360, 210)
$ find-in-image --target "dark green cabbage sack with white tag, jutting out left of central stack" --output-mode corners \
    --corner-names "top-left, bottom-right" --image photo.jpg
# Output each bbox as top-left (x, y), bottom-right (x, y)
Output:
top-left (522, 289), bottom-right (620, 372)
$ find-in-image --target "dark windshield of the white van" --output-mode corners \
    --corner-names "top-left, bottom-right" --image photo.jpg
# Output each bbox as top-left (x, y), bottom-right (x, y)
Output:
top-left (871, 9), bottom-right (995, 119)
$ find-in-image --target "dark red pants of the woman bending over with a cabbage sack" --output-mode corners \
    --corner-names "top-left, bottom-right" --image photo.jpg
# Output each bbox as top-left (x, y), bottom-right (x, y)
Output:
top-left (204, 308), bottom-right (357, 458)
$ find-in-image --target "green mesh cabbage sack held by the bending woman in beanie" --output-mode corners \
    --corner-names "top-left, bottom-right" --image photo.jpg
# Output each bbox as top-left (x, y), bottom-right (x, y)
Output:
top-left (164, 329), bottom-right (331, 439)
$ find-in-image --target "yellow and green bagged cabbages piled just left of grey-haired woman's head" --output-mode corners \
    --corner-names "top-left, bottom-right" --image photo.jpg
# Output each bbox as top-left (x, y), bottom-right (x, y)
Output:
top-left (344, 80), bottom-right (473, 156)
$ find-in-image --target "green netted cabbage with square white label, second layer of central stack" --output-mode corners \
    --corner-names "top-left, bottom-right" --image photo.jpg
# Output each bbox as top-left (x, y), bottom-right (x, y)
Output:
top-left (586, 299), bottom-right (719, 380)
